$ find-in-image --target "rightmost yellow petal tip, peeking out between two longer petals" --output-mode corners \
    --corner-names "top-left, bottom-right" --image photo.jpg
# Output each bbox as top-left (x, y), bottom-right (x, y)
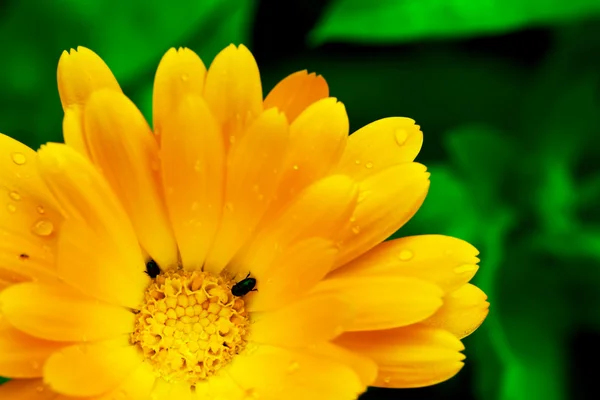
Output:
top-left (423, 283), bottom-right (490, 339)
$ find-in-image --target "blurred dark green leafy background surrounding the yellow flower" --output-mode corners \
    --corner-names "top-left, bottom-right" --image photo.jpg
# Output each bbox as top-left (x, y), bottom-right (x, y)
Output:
top-left (0, 0), bottom-right (600, 400)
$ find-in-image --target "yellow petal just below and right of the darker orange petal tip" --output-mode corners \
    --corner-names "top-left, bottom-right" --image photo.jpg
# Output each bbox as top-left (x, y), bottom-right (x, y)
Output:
top-left (271, 98), bottom-right (349, 210)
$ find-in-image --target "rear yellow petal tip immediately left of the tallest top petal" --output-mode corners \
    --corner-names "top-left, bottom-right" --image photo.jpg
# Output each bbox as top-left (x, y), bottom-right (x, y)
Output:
top-left (152, 48), bottom-right (206, 143)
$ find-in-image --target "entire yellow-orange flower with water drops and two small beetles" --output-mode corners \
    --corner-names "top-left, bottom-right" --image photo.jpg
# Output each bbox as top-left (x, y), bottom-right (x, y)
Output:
top-left (0, 46), bottom-right (488, 400)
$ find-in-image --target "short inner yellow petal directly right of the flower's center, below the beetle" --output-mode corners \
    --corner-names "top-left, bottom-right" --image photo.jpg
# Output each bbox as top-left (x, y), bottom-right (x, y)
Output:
top-left (250, 293), bottom-right (354, 347)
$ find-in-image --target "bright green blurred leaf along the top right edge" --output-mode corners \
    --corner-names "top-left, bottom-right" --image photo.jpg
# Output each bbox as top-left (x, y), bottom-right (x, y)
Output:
top-left (310, 0), bottom-right (600, 44)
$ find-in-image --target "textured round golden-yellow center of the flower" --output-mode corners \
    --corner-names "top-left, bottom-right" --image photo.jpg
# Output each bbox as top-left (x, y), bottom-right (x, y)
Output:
top-left (131, 271), bottom-right (250, 385)
